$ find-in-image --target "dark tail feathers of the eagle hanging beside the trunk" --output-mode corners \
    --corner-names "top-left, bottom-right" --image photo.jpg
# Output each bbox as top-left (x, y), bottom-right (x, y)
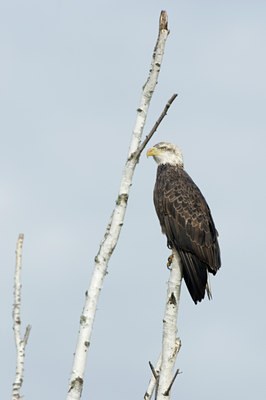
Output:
top-left (178, 250), bottom-right (211, 304)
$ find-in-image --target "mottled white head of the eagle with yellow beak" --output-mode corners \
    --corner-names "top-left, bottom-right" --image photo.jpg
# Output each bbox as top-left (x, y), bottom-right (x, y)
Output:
top-left (147, 142), bottom-right (184, 168)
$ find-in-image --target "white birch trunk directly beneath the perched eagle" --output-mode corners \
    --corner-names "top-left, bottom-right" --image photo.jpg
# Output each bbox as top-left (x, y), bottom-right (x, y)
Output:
top-left (157, 250), bottom-right (182, 400)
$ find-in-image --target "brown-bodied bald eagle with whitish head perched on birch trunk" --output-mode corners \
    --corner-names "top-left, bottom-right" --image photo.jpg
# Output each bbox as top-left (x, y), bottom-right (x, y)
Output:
top-left (147, 142), bottom-right (221, 304)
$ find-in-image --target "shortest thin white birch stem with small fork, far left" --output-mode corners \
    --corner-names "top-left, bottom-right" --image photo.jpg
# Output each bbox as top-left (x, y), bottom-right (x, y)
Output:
top-left (12, 234), bottom-right (31, 400)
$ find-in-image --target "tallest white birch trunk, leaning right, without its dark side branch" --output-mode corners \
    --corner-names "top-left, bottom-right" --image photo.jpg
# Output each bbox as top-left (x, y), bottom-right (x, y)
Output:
top-left (67, 11), bottom-right (169, 400)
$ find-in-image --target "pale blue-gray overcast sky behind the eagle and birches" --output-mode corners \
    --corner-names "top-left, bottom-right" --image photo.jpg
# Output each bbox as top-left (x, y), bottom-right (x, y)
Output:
top-left (0, 0), bottom-right (266, 400)
